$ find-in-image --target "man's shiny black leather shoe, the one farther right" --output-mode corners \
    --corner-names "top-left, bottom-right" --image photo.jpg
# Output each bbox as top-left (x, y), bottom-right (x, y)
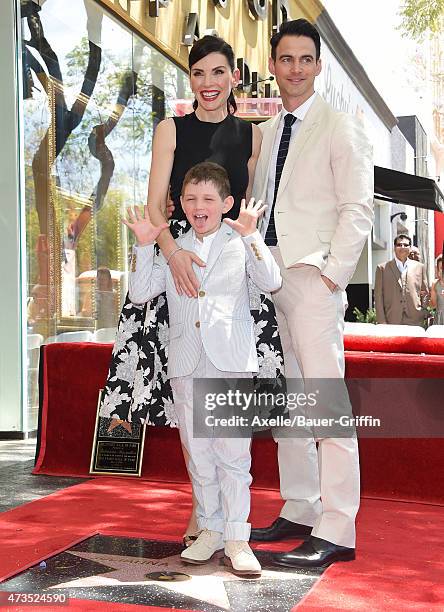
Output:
top-left (272, 536), bottom-right (355, 569)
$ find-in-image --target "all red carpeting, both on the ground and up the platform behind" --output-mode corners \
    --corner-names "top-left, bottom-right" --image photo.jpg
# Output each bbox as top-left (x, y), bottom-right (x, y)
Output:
top-left (20, 339), bottom-right (444, 611)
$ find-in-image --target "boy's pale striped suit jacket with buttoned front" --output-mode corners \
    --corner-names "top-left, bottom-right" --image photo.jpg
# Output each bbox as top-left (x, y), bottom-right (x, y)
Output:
top-left (129, 223), bottom-right (282, 378)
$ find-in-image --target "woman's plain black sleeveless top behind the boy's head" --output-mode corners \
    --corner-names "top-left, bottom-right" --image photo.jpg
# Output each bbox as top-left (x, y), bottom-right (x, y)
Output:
top-left (170, 113), bottom-right (253, 221)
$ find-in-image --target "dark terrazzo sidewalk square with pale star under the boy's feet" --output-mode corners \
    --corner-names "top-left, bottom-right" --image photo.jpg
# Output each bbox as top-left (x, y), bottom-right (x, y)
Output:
top-left (0, 535), bottom-right (320, 612)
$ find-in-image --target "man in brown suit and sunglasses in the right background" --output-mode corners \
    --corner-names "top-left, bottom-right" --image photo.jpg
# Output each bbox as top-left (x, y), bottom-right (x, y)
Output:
top-left (375, 234), bottom-right (429, 325)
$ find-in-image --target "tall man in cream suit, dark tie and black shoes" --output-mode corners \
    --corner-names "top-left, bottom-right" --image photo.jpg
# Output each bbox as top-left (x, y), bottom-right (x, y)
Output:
top-left (251, 19), bottom-right (373, 568)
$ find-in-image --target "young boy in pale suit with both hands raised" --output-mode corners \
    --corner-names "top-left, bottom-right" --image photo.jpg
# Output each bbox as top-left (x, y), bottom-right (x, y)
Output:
top-left (124, 162), bottom-right (282, 576)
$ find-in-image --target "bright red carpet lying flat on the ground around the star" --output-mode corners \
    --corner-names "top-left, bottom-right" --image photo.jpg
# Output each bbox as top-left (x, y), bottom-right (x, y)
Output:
top-left (0, 478), bottom-right (444, 611)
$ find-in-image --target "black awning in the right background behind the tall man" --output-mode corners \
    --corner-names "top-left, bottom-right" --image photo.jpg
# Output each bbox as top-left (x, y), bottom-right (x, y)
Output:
top-left (375, 166), bottom-right (444, 212)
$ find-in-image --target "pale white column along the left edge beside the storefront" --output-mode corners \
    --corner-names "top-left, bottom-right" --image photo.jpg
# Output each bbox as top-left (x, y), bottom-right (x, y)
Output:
top-left (0, 0), bottom-right (26, 437)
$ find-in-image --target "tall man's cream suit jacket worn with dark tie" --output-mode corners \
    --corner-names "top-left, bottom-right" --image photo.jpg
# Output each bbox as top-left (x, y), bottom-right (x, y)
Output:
top-left (253, 95), bottom-right (373, 289)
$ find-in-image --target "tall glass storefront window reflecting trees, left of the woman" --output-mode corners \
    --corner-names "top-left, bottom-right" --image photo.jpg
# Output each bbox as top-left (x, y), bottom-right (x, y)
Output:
top-left (20, 0), bottom-right (191, 429)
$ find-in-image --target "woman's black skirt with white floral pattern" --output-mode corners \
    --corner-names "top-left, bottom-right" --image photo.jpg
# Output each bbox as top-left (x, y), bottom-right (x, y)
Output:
top-left (100, 221), bottom-right (284, 427)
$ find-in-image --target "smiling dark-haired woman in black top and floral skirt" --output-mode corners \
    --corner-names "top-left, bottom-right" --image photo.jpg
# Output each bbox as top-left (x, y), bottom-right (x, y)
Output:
top-left (101, 36), bottom-right (283, 534)
